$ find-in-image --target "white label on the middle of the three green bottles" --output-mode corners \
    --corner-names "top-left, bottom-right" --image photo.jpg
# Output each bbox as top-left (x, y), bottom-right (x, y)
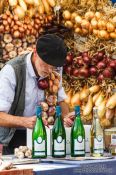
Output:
top-left (54, 136), bottom-right (65, 155)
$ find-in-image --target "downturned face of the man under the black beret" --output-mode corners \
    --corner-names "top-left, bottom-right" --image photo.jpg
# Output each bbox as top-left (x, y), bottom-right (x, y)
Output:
top-left (34, 53), bottom-right (55, 77)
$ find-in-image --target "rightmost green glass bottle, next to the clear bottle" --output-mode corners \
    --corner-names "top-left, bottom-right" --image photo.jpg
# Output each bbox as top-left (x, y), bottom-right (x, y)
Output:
top-left (71, 106), bottom-right (85, 157)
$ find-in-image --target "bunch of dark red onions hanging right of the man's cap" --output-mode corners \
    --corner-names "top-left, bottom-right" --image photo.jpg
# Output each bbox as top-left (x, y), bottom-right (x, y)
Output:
top-left (64, 51), bottom-right (116, 81)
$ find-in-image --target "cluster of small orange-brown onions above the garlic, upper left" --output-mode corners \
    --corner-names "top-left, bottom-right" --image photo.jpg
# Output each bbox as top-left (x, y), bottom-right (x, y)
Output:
top-left (0, 11), bottom-right (53, 38)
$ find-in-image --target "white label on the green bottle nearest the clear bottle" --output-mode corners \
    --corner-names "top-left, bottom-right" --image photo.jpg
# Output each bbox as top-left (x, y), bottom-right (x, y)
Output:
top-left (74, 136), bottom-right (85, 154)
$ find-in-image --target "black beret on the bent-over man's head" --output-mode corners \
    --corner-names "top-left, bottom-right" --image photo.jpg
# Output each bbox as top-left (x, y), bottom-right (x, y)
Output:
top-left (36, 34), bottom-right (67, 67)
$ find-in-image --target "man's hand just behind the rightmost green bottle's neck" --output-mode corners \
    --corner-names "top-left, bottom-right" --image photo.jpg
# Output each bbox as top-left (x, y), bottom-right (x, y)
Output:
top-left (64, 112), bottom-right (75, 127)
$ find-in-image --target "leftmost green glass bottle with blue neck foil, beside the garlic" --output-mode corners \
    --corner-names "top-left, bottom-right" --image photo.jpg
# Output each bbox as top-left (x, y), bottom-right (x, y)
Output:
top-left (32, 106), bottom-right (47, 158)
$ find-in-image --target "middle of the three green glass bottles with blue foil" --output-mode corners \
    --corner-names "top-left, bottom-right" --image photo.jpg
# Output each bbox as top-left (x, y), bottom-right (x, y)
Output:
top-left (52, 106), bottom-right (66, 158)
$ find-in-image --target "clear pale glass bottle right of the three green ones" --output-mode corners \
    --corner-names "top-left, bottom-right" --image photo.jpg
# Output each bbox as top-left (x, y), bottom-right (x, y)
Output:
top-left (90, 107), bottom-right (104, 156)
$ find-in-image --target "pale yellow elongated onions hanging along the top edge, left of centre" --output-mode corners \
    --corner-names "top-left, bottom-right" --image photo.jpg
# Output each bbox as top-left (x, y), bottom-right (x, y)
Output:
top-left (8, 0), bottom-right (55, 19)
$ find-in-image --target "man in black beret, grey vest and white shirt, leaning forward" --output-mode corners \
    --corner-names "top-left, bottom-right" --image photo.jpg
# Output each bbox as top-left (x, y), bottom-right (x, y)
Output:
top-left (0, 34), bottom-right (72, 154)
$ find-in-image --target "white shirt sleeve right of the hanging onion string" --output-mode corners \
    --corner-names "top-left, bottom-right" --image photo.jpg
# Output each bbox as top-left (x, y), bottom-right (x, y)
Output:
top-left (58, 67), bottom-right (67, 102)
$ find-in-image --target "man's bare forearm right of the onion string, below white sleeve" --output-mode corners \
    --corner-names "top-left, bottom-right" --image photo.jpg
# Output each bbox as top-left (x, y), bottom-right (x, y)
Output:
top-left (59, 101), bottom-right (69, 118)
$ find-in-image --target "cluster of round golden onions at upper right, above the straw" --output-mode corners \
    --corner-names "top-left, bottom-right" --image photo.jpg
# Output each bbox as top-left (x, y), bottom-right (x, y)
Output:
top-left (62, 10), bottom-right (116, 40)
